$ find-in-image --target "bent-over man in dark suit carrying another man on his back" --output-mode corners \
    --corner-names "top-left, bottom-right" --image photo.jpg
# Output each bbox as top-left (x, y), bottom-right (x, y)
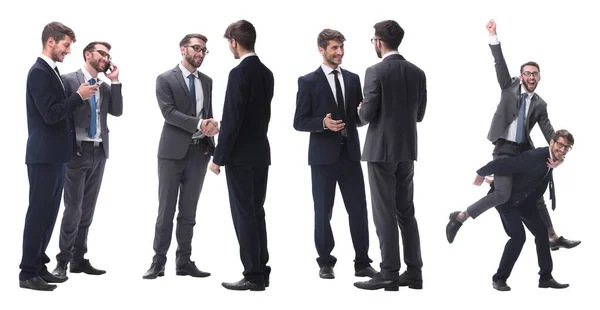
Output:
top-left (474, 129), bottom-right (575, 291)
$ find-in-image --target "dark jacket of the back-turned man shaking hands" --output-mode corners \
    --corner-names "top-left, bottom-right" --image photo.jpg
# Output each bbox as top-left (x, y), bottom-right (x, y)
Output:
top-left (213, 56), bottom-right (275, 166)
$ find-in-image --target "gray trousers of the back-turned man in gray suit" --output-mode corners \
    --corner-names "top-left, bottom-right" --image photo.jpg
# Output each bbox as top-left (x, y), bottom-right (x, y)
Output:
top-left (368, 161), bottom-right (423, 280)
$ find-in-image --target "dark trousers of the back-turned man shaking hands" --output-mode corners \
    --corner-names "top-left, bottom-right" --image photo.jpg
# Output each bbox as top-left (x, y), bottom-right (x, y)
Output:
top-left (225, 165), bottom-right (271, 284)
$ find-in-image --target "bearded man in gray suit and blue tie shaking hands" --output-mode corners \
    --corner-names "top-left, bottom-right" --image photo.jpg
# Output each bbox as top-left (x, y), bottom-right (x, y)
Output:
top-left (143, 34), bottom-right (218, 279)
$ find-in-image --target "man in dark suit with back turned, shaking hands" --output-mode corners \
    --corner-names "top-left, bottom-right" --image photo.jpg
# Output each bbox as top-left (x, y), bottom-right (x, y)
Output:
top-left (210, 20), bottom-right (274, 291)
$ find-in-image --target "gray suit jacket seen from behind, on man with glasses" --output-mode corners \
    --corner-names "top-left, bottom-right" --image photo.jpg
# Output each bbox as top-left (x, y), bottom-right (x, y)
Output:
top-left (359, 54), bottom-right (427, 162)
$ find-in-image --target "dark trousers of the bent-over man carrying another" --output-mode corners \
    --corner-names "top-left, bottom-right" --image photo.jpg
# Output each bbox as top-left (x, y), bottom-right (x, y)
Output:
top-left (492, 200), bottom-right (552, 281)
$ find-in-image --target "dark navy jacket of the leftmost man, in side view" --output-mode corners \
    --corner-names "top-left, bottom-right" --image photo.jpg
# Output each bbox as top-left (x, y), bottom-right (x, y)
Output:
top-left (25, 58), bottom-right (83, 164)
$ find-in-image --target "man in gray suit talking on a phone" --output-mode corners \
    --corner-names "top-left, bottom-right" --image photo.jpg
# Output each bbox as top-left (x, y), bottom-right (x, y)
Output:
top-left (52, 42), bottom-right (123, 278)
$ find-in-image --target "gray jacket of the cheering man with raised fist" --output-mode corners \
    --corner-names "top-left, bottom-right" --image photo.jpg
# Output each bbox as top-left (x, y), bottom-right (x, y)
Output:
top-left (488, 44), bottom-right (554, 148)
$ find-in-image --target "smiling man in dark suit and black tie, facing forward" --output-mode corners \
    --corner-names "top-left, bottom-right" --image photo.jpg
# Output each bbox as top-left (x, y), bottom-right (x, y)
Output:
top-left (294, 29), bottom-right (377, 279)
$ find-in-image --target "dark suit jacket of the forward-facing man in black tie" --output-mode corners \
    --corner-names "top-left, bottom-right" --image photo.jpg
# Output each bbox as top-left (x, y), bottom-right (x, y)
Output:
top-left (294, 67), bottom-right (363, 165)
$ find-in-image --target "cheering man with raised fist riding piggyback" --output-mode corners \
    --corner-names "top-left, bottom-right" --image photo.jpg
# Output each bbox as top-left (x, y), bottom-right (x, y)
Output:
top-left (446, 20), bottom-right (581, 250)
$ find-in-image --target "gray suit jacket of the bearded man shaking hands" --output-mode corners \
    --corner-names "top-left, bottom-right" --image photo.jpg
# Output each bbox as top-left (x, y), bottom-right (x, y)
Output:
top-left (156, 65), bottom-right (215, 159)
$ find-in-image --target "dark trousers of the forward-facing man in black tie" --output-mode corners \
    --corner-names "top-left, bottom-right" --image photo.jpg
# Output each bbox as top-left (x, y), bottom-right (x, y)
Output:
top-left (311, 144), bottom-right (372, 271)
